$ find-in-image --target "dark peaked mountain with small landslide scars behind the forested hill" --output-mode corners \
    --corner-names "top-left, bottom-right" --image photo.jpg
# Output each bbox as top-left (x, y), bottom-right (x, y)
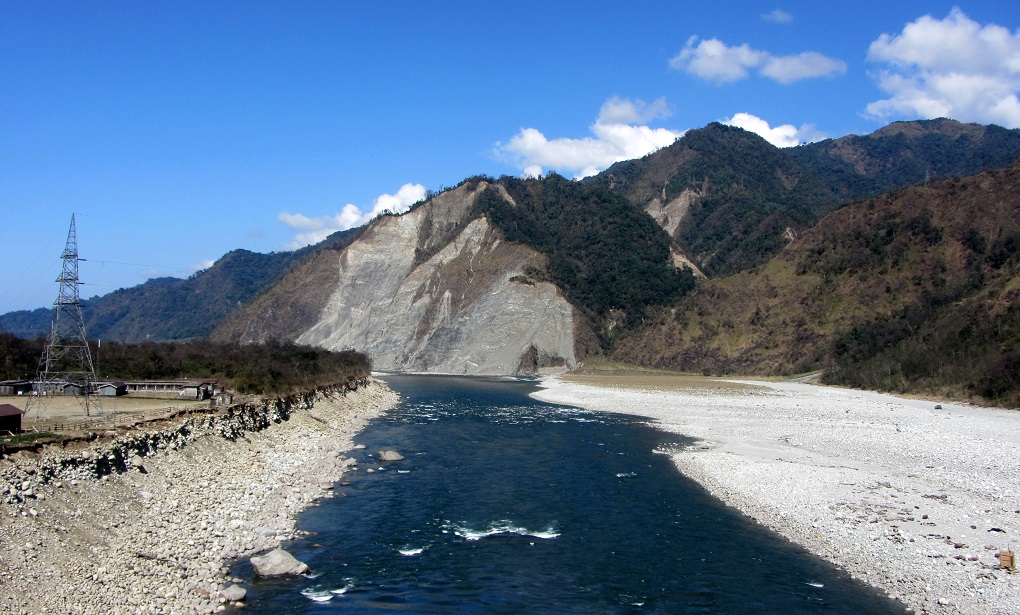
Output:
top-left (592, 123), bottom-right (835, 276)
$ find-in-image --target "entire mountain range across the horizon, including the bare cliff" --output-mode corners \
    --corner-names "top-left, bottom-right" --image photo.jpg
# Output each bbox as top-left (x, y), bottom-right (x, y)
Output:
top-left (0, 119), bottom-right (1020, 405)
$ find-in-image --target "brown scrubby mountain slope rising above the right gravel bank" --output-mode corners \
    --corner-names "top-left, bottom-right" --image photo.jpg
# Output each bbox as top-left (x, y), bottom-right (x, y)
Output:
top-left (615, 163), bottom-right (1020, 405)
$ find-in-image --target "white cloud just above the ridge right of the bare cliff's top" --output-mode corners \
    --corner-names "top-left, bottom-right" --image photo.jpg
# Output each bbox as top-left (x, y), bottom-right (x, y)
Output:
top-left (495, 97), bottom-right (683, 177)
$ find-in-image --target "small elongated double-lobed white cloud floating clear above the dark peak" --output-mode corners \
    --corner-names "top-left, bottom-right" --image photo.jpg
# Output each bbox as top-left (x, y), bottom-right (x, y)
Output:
top-left (669, 37), bottom-right (847, 85)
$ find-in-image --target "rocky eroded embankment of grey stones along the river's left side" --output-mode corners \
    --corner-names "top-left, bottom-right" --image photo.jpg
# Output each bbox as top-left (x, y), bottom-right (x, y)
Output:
top-left (0, 380), bottom-right (398, 615)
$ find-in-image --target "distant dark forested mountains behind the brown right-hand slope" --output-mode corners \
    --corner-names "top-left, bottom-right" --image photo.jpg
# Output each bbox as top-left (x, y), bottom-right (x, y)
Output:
top-left (588, 119), bottom-right (1020, 276)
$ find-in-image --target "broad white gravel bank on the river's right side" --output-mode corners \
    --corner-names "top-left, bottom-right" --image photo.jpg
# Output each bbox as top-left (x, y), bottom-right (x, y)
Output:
top-left (534, 376), bottom-right (1020, 615)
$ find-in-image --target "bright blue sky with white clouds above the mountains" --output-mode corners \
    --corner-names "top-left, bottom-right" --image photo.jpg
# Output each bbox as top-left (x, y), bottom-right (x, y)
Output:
top-left (0, 0), bottom-right (1020, 313)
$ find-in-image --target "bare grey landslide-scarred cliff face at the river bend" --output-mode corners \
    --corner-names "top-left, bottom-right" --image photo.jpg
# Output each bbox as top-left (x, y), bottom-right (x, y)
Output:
top-left (220, 183), bottom-right (576, 374)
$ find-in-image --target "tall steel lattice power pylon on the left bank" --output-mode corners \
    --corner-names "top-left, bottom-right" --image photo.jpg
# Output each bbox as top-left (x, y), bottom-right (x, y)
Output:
top-left (30, 214), bottom-right (102, 419)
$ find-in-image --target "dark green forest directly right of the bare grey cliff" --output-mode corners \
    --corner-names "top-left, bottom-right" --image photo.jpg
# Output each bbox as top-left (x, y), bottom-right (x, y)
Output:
top-left (475, 174), bottom-right (695, 326)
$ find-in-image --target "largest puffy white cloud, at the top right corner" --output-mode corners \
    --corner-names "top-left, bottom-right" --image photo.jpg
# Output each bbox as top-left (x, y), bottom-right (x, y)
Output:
top-left (865, 8), bottom-right (1020, 129)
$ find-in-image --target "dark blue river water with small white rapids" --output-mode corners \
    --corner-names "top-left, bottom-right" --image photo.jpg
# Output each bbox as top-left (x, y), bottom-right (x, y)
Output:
top-left (234, 375), bottom-right (904, 614)
